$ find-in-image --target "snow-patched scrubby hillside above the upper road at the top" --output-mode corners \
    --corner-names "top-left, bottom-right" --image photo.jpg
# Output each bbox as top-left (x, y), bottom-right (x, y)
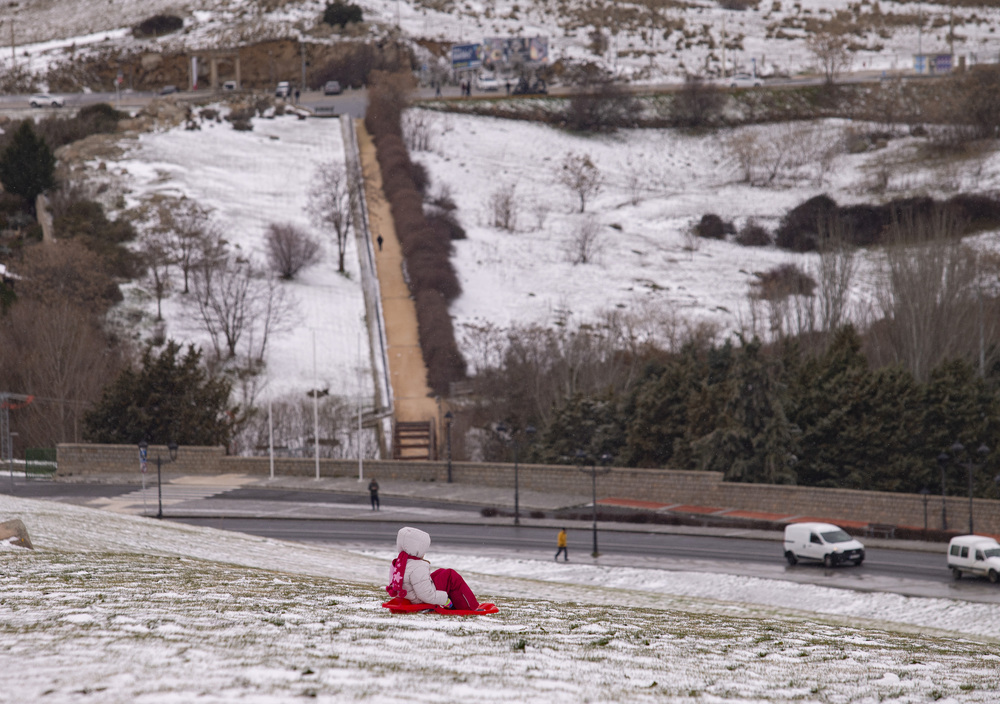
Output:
top-left (7, 0), bottom-right (1000, 87)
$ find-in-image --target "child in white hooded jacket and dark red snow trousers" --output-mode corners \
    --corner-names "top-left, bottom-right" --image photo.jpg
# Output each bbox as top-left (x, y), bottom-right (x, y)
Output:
top-left (385, 526), bottom-right (479, 611)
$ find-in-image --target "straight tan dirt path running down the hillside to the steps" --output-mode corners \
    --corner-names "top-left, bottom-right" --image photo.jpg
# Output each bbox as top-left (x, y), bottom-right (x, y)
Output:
top-left (356, 120), bottom-right (438, 428)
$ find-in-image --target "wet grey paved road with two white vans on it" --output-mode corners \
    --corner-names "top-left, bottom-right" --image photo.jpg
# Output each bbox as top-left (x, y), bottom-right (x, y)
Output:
top-left (9, 477), bottom-right (1000, 603)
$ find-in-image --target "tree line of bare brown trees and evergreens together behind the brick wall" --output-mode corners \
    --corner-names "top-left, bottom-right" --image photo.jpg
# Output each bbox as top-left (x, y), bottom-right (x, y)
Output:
top-left (463, 325), bottom-right (1000, 498)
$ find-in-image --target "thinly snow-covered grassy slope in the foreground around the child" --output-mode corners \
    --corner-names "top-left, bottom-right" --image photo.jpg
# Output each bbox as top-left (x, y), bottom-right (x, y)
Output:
top-left (0, 496), bottom-right (1000, 703)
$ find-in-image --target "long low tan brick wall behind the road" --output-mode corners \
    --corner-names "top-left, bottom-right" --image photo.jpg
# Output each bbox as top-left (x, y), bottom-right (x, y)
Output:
top-left (58, 444), bottom-right (1000, 535)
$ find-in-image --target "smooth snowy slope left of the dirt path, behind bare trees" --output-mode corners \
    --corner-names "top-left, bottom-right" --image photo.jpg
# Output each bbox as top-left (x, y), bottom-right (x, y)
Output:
top-left (115, 115), bottom-right (373, 398)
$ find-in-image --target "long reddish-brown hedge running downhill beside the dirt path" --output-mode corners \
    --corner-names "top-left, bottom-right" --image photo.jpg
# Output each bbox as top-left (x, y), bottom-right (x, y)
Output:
top-left (365, 76), bottom-right (466, 396)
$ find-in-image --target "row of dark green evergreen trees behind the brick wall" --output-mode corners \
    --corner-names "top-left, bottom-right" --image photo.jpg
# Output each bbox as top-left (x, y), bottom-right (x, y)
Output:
top-left (527, 326), bottom-right (1000, 498)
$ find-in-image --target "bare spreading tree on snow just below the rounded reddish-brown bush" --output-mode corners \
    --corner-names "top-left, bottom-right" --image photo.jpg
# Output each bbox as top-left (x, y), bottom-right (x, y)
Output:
top-left (192, 253), bottom-right (292, 361)
